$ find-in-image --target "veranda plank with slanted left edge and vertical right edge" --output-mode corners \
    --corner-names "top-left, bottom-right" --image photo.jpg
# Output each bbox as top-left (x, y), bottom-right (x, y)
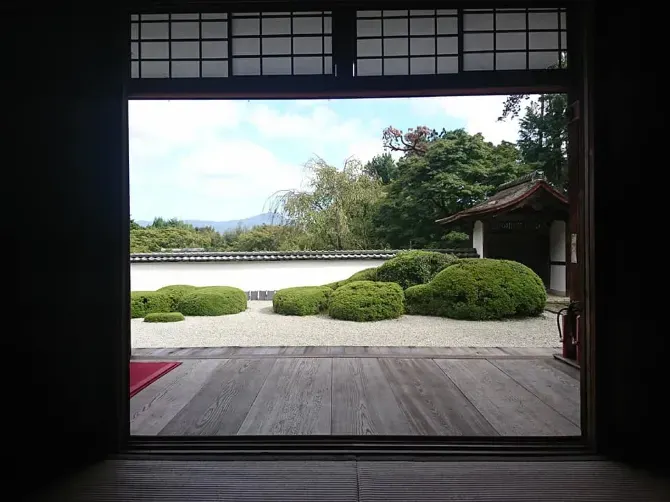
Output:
top-left (238, 358), bottom-right (332, 435)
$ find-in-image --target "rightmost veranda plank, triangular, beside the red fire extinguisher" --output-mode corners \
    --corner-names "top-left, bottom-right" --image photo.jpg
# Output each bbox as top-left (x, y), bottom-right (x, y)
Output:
top-left (490, 359), bottom-right (580, 427)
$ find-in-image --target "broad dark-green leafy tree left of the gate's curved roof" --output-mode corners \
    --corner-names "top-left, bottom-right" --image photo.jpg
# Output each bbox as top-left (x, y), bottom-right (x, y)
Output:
top-left (375, 129), bottom-right (531, 248)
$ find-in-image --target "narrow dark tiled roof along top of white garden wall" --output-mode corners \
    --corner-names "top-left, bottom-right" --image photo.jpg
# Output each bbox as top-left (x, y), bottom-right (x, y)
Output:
top-left (130, 248), bottom-right (478, 263)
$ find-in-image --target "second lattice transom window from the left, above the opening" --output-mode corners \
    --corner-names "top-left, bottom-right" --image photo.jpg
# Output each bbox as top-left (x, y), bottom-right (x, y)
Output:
top-left (231, 12), bottom-right (333, 76)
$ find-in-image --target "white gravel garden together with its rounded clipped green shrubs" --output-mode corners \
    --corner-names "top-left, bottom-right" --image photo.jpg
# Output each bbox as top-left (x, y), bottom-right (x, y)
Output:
top-left (131, 251), bottom-right (559, 348)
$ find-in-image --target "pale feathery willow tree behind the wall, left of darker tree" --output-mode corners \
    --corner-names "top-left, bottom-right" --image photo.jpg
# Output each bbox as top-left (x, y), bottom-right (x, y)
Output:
top-left (271, 157), bottom-right (384, 249)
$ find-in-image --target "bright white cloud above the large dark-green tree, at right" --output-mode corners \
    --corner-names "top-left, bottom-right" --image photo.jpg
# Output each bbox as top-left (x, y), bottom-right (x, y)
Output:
top-left (415, 96), bottom-right (540, 144)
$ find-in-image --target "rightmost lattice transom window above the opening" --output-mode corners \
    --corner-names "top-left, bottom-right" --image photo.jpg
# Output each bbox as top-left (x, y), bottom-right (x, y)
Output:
top-left (463, 9), bottom-right (567, 71)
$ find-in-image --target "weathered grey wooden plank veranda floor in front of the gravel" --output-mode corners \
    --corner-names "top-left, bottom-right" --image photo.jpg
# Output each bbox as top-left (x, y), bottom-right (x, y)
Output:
top-left (130, 347), bottom-right (580, 436)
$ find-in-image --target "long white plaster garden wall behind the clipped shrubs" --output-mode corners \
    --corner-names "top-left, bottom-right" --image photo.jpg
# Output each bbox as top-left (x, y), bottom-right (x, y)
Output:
top-left (130, 260), bottom-right (386, 291)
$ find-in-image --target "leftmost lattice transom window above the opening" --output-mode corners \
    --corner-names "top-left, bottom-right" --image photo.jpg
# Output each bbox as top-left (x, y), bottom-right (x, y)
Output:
top-left (130, 13), bottom-right (229, 78)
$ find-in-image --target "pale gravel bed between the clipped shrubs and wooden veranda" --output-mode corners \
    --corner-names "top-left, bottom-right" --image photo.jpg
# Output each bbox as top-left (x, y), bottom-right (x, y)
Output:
top-left (131, 301), bottom-right (560, 348)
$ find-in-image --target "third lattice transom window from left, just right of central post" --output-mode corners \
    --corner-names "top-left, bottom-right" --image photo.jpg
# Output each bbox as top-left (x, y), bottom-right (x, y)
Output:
top-left (356, 9), bottom-right (459, 76)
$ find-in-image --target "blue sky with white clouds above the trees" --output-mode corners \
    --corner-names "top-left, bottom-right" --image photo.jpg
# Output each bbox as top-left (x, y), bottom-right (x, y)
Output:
top-left (129, 96), bottom-right (518, 221)
